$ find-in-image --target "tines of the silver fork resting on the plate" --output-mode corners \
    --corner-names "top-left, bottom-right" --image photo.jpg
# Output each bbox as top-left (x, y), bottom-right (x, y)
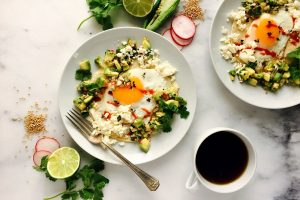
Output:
top-left (66, 108), bottom-right (93, 136)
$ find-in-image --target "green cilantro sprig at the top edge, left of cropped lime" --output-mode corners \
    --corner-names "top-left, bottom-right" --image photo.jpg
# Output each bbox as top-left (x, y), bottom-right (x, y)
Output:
top-left (77, 0), bottom-right (123, 30)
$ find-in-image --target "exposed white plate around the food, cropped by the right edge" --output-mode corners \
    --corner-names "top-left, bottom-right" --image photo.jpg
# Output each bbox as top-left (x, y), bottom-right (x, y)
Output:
top-left (210, 0), bottom-right (300, 109)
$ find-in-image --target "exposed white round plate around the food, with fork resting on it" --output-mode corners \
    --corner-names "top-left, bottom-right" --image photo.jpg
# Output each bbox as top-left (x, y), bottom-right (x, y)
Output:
top-left (59, 28), bottom-right (197, 164)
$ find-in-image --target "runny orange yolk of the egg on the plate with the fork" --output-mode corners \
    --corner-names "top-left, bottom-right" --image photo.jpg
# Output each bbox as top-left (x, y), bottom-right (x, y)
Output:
top-left (113, 77), bottom-right (144, 105)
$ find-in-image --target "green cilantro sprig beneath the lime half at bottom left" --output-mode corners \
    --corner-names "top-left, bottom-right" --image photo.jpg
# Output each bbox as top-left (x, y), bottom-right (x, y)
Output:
top-left (34, 156), bottom-right (109, 200)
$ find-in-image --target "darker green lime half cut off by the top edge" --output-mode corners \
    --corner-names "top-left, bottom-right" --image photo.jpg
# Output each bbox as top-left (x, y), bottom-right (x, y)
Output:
top-left (123, 0), bottom-right (153, 17)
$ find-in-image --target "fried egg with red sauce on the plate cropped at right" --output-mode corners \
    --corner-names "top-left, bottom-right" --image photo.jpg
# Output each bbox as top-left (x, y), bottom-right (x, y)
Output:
top-left (245, 10), bottom-right (293, 60)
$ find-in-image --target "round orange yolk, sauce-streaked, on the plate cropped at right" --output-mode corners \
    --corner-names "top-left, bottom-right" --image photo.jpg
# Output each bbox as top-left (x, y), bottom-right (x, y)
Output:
top-left (255, 19), bottom-right (280, 49)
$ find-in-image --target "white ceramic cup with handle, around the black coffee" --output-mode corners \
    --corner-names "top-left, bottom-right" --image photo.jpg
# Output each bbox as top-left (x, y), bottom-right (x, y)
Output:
top-left (185, 127), bottom-right (256, 193)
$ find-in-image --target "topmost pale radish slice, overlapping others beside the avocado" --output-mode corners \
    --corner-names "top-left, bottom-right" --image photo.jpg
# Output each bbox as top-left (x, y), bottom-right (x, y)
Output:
top-left (172, 15), bottom-right (196, 40)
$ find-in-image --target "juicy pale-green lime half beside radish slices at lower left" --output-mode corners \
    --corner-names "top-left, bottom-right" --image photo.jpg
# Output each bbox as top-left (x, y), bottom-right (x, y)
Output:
top-left (47, 147), bottom-right (80, 179)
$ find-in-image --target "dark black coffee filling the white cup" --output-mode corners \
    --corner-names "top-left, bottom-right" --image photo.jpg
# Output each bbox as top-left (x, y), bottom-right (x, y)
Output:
top-left (196, 131), bottom-right (248, 184)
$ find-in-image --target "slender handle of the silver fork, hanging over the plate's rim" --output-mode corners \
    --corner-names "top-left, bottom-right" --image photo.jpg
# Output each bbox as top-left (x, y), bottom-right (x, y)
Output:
top-left (101, 142), bottom-right (159, 191)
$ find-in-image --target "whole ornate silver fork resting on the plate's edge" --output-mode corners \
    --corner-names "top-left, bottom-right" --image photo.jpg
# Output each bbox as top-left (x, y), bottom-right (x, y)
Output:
top-left (66, 108), bottom-right (159, 191)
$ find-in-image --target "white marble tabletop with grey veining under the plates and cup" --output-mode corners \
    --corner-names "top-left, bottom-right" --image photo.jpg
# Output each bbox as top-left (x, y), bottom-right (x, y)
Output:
top-left (0, 0), bottom-right (300, 200)
